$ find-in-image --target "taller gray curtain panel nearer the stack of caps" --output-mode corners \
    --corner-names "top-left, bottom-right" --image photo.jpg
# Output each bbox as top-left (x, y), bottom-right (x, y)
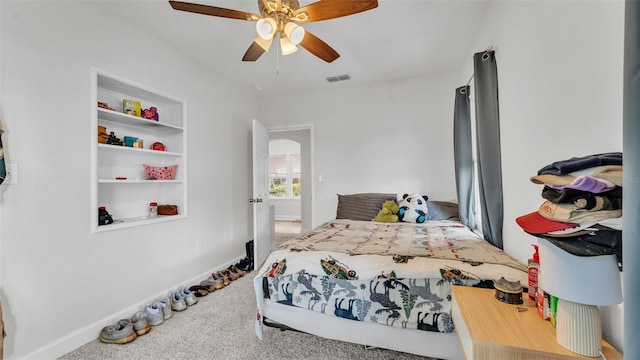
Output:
top-left (473, 50), bottom-right (504, 249)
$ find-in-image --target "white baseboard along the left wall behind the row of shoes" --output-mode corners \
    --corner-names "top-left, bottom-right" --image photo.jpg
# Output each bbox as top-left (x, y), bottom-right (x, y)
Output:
top-left (22, 256), bottom-right (244, 360)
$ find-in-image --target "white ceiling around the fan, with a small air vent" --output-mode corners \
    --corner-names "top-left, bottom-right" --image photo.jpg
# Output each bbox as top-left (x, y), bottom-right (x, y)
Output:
top-left (99, 0), bottom-right (489, 92)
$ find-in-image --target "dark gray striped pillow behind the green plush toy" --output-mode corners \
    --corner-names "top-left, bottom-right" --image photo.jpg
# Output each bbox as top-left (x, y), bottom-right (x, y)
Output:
top-left (336, 193), bottom-right (397, 221)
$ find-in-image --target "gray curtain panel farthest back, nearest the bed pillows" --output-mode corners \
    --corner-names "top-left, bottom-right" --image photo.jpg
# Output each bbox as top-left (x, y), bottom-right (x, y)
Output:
top-left (453, 85), bottom-right (476, 229)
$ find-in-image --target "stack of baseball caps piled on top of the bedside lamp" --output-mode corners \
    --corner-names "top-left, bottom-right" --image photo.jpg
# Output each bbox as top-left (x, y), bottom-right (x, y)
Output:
top-left (516, 152), bottom-right (623, 264)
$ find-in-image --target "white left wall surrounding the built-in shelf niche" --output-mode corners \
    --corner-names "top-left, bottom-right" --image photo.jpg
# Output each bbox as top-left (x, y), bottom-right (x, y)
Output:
top-left (0, 1), bottom-right (256, 359)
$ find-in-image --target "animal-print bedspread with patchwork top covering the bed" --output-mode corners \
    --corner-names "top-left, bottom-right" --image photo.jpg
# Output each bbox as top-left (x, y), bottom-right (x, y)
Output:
top-left (261, 220), bottom-right (527, 332)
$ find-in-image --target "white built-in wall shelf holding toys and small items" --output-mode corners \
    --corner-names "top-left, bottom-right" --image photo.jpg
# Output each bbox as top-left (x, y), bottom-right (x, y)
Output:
top-left (90, 68), bottom-right (188, 233)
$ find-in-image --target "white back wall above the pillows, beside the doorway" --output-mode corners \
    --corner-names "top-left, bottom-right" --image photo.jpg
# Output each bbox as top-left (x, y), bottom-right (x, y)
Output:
top-left (260, 74), bottom-right (457, 226)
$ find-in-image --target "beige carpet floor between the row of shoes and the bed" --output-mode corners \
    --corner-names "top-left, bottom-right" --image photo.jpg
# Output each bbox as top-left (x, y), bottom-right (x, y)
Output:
top-left (60, 271), bottom-right (436, 360)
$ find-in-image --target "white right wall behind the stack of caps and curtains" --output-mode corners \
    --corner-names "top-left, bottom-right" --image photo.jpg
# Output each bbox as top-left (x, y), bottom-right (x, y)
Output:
top-left (458, 1), bottom-right (624, 350)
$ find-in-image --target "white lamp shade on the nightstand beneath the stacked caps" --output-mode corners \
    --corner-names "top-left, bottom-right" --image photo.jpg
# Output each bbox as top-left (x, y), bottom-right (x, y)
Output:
top-left (538, 238), bottom-right (622, 305)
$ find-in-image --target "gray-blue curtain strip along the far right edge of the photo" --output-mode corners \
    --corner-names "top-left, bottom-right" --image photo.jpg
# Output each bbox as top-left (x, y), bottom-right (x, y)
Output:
top-left (622, 0), bottom-right (640, 359)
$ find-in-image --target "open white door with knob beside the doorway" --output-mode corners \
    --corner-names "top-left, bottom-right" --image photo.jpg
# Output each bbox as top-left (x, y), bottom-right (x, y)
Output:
top-left (249, 120), bottom-right (275, 270)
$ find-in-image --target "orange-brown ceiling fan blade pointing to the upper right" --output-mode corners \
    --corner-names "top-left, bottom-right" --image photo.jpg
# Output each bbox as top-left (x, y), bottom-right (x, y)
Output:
top-left (293, 0), bottom-right (378, 22)
